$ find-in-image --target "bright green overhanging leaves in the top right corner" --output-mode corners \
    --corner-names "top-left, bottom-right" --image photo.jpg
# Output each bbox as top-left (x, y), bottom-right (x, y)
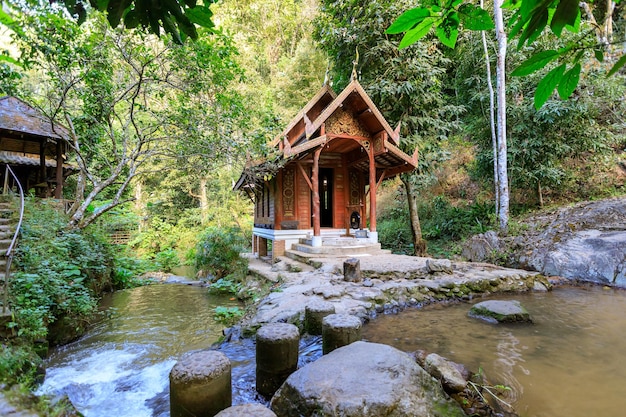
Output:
top-left (387, 0), bottom-right (626, 109)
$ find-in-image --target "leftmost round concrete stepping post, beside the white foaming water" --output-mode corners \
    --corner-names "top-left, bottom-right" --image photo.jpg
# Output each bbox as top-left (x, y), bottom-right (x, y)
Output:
top-left (170, 350), bottom-right (232, 417)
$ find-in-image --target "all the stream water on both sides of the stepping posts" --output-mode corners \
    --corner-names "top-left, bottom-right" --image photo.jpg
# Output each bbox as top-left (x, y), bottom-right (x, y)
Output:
top-left (39, 284), bottom-right (626, 417)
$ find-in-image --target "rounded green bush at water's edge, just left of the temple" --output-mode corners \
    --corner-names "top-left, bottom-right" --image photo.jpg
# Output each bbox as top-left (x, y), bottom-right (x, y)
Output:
top-left (196, 227), bottom-right (248, 283)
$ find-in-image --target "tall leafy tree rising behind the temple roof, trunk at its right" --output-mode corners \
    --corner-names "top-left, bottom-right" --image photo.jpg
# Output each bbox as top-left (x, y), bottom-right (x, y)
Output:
top-left (316, 0), bottom-right (462, 255)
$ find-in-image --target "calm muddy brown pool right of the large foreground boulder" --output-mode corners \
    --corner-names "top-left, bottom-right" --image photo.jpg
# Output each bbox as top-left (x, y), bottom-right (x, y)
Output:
top-left (363, 287), bottom-right (626, 417)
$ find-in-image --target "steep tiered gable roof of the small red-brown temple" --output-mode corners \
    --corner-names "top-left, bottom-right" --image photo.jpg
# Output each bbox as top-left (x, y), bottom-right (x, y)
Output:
top-left (235, 80), bottom-right (417, 189)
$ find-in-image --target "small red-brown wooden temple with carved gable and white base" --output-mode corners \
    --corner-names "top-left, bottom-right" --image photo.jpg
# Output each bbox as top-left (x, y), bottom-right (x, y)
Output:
top-left (235, 77), bottom-right (417, 257)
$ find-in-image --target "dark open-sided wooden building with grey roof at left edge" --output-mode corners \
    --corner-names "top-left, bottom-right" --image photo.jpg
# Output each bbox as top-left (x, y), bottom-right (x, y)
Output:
top-left (0, 96), bottom-right (74, 199)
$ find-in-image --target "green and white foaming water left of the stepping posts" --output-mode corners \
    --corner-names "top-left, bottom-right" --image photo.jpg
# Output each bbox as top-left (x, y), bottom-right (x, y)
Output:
top-left (39, 285), bottom-right (238, 417)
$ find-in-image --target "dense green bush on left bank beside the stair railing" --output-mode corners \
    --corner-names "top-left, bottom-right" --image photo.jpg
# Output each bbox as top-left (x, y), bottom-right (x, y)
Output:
top-left (9, 201), bottom-right (113, 340)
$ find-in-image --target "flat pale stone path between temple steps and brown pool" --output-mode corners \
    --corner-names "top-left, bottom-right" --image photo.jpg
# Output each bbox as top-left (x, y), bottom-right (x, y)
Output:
top-left (242, 255), bottom-right (551, 329)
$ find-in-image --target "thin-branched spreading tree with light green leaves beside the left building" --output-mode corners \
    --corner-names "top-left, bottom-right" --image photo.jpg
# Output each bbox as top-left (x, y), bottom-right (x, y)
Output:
top-left (12, 9), bottom-right (246, 228)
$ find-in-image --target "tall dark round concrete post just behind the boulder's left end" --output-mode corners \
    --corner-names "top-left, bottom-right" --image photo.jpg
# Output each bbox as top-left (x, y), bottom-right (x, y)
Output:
top-left (256, 323), bottom-right (300, 398)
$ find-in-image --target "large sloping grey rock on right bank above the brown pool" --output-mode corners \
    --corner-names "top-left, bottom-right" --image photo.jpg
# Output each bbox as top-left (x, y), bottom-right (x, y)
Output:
top-left (463, 197), bottom-right (626, 288)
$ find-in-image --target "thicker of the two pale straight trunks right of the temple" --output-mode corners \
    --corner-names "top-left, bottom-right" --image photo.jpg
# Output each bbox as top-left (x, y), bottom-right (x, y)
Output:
top-left (493, 0), bottom-right (509, 233)
